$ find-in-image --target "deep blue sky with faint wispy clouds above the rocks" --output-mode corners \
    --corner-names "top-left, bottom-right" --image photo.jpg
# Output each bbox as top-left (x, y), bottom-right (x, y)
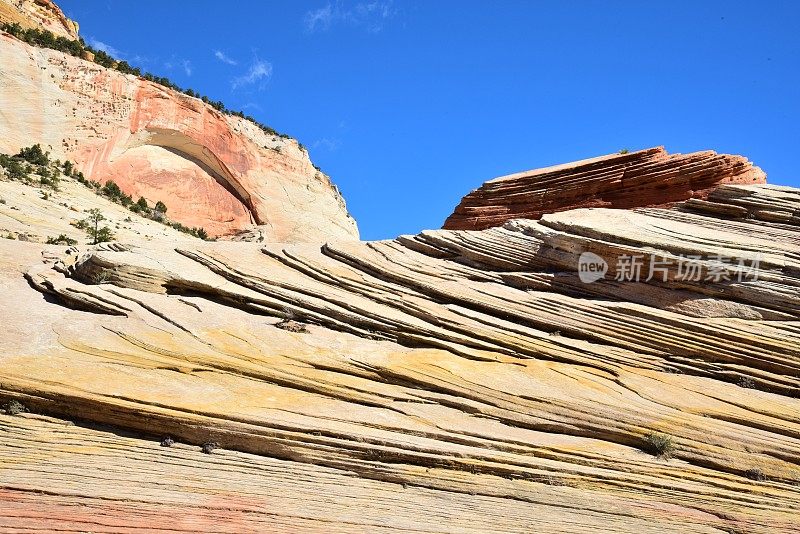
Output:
top-left (59, 0), bottom-right (800, 239)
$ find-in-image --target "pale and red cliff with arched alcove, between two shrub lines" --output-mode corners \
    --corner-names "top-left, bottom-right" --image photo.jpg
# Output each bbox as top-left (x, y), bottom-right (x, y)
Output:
top-left (0, 31), bottom-right (358, 242)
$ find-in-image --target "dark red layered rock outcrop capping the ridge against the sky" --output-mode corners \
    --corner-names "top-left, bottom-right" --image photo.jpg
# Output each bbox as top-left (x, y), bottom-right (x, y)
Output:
top-left (444, 147), bottom-right (766, 230)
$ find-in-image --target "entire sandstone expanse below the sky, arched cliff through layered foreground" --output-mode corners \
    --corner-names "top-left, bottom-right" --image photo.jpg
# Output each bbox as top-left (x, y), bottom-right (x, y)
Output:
top-left (0, 0), bottom-right (800, 534)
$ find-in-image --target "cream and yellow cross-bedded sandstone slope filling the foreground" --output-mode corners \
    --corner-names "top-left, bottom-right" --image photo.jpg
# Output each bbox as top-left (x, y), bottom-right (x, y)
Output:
top-left (0, 175), bottom-right (800, 533)
